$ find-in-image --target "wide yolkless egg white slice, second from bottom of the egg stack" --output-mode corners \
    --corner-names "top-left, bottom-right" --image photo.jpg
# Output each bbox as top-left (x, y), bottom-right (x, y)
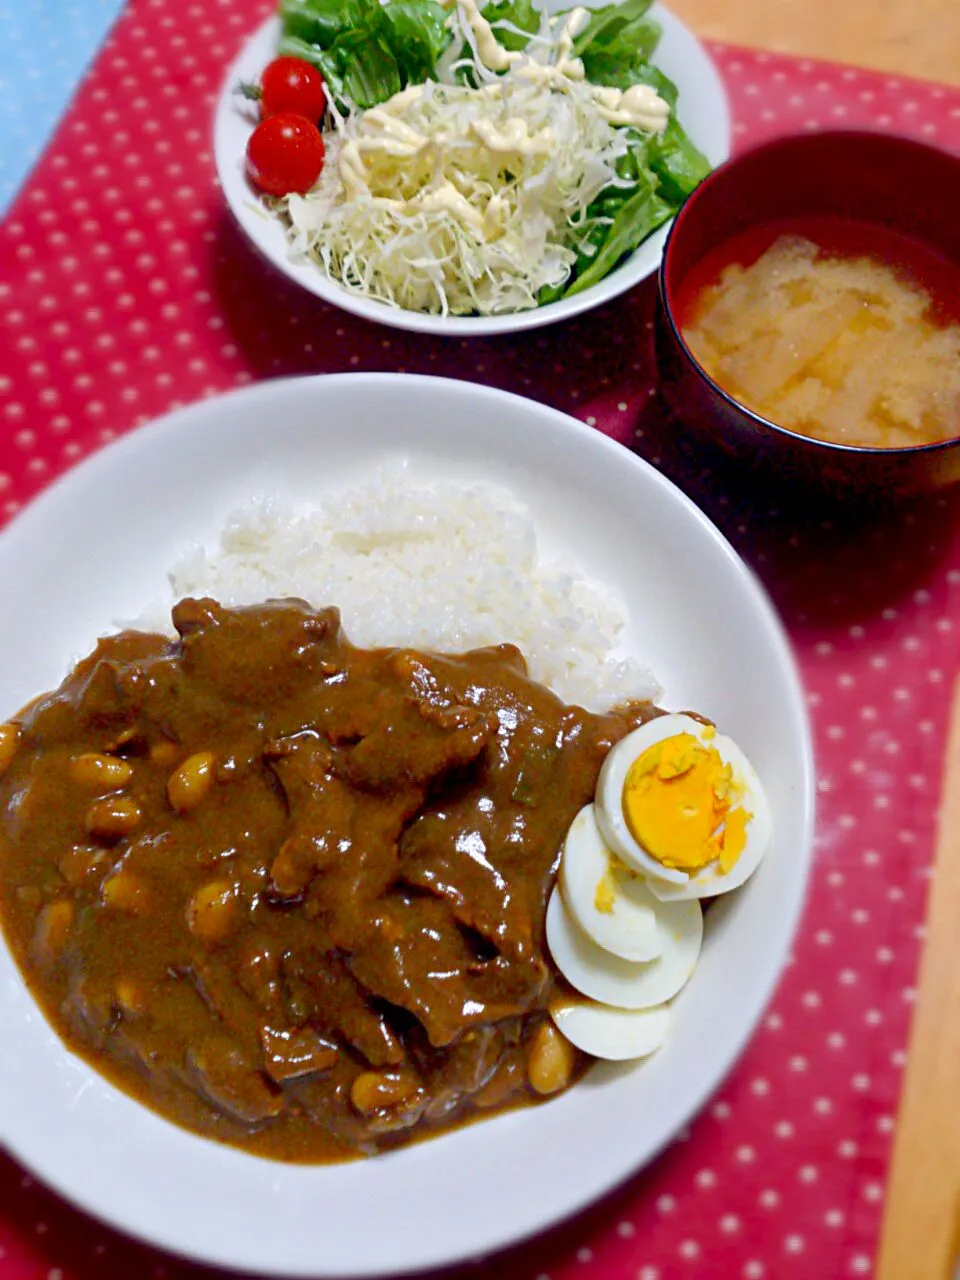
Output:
top-left (547, 886), bottom-right (703, 1009)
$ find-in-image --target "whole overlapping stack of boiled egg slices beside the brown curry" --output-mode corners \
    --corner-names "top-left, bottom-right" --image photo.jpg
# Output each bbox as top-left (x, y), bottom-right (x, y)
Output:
top-left (547, 714), bottom-right (771, 1059)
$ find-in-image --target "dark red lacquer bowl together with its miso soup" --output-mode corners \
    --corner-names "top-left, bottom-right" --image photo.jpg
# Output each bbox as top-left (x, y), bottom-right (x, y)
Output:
top-left (657, 131), bottom-right (960, 498)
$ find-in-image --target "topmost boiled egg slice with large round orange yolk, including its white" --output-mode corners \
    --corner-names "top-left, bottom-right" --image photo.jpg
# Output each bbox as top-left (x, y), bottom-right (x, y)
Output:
top-left (596, 714), bottom-right (771, 901)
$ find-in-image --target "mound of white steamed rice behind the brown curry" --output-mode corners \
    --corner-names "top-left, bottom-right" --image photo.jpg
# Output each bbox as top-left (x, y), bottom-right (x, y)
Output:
top-left (148, 467), bottom-right (660, 709)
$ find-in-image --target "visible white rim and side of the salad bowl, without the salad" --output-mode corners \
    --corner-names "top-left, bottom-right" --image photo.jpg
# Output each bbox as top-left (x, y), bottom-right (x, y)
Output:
top-left (214, 0), bottom-right (731, 338)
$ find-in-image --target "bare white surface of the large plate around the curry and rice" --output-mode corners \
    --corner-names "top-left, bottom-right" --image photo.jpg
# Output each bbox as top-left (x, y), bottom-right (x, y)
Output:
top-left (0, 374), bottom-right (814, 1276)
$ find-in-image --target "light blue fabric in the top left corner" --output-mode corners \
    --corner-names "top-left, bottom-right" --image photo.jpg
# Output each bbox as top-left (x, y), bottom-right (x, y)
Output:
top-left (0, 0), bottom-right (124, 214)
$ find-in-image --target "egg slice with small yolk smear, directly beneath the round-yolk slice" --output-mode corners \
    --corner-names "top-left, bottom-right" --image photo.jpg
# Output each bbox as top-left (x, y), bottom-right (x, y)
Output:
top-left (559, 804), bottom-right (662, 960)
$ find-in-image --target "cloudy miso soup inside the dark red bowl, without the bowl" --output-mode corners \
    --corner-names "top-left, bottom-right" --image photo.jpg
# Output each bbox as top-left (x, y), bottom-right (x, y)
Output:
top-left (684, 236), bottom-right (960, 448)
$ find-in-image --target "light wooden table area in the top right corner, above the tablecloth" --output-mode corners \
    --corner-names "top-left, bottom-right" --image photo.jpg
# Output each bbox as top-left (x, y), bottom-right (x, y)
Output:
top-left (669, 0), bottom-right (960, 84)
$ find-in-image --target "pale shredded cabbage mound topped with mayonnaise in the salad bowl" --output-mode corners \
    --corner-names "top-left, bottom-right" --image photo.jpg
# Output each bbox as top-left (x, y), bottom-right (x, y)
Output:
top-left (283, 10), bottom-right (660, 315)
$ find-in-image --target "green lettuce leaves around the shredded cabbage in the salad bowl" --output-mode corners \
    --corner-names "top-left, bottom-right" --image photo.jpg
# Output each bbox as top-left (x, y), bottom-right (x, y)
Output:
top-left (273, 0), bottom-right (710, 303)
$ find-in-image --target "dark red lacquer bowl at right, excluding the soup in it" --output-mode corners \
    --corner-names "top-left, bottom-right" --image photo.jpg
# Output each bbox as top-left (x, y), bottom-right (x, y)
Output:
top-left (657, 131), bottom-right (960, 498)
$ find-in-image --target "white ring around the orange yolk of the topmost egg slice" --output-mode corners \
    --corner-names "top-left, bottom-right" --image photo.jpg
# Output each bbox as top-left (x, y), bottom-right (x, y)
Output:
top-left (596, 714), bottom-right (773, 901)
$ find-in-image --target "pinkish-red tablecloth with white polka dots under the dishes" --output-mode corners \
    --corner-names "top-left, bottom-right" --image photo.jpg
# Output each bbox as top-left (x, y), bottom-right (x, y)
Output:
top-left (0, 0), bottom-right (960, 1280)
